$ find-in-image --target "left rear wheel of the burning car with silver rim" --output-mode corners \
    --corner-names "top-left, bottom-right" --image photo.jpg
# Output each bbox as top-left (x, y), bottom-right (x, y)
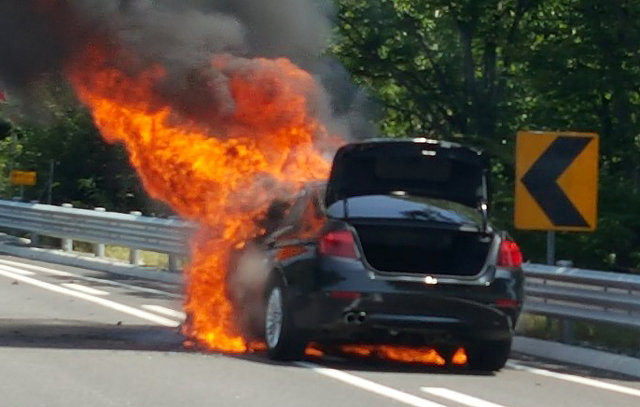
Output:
top-left (264, 279), bottom-right (306, 360)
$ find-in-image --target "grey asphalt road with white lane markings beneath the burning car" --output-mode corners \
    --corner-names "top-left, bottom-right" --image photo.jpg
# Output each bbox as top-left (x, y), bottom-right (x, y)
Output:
top-left (0, 255), bottom-right (640, 407)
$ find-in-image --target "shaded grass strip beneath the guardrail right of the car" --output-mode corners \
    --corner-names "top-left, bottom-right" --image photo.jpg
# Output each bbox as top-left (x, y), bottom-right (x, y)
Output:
top-left (517, 314), bottom-right (640, 357)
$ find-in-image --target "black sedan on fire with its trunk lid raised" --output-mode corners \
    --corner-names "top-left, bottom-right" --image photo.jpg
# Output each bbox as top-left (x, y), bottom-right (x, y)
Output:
top-left (227, 139), bottom-right (523, 370)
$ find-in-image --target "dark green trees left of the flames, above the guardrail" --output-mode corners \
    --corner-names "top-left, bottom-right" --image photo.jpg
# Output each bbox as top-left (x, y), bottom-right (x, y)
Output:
top-left (0, 81), bottom-right (166, 213)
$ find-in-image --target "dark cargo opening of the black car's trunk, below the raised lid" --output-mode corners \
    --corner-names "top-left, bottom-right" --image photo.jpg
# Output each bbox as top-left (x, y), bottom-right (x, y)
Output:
top-left (352, 223), bottom-right (493, 277)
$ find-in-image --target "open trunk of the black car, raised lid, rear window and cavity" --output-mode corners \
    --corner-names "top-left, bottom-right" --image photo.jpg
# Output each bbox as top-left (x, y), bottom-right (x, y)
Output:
top-left (325, 139), bottom-right (493, 277)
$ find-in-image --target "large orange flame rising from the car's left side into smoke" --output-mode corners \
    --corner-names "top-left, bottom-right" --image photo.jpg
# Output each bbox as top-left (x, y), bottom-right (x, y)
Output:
top-left (70, 44), bottom-right (339, 352)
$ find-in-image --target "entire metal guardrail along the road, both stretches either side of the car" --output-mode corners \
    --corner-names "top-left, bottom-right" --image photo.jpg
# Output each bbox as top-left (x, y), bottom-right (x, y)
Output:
top-left (0, 200), bottom-right (640, 329)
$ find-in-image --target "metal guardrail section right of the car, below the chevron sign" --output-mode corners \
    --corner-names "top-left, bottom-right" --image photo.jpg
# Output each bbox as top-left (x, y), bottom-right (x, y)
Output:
top-left (523, 264), bottom-right (640, 329)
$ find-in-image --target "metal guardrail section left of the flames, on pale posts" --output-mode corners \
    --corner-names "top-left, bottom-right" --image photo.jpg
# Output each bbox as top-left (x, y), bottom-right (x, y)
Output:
top-left (0, 200), bottom-right (197, 271)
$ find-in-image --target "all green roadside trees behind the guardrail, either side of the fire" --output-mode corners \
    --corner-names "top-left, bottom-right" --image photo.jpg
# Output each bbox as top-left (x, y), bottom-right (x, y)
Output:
top-left (0, 0), bottom-right (640, 272)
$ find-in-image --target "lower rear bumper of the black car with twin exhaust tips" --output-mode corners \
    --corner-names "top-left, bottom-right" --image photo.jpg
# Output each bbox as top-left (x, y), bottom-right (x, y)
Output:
top-left (294, 293), bottom-right (512, 342)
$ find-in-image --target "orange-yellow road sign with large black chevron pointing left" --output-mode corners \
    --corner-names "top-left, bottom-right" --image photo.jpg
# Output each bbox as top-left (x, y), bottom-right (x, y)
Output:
top-left (515, 131), bottom-right (599, 231)
